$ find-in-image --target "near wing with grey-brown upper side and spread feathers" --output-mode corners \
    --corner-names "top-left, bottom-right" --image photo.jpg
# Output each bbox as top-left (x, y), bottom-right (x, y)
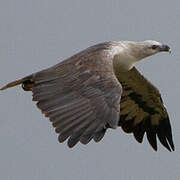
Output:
top-left (32, 52), bottom-right (122, 147)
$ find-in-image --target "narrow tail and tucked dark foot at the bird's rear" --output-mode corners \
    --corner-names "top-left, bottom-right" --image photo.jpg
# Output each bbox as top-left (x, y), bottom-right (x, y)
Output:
top-left (0, 75), bottom-right (34, 91)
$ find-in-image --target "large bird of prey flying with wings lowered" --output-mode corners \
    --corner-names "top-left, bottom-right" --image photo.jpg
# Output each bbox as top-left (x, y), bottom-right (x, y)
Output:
top-left (0, 40), bottom-right (174, 151)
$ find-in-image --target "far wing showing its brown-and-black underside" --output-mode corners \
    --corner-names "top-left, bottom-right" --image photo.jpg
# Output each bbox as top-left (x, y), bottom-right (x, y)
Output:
top-left (117, 67), bottom-right (174, 151)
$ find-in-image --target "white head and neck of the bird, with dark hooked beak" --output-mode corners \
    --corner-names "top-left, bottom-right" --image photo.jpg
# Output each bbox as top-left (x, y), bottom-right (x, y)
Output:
top-left (113, 40), bottom-right (171, 71)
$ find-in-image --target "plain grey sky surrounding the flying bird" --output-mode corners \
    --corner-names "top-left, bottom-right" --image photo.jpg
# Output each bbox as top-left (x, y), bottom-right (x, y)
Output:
top-left (0, 0), bottom-right (180, 180)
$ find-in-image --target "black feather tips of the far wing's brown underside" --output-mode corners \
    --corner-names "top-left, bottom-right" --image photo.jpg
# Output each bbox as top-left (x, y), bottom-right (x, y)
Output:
top-left (119, 115), bottom-right (175, 152)
